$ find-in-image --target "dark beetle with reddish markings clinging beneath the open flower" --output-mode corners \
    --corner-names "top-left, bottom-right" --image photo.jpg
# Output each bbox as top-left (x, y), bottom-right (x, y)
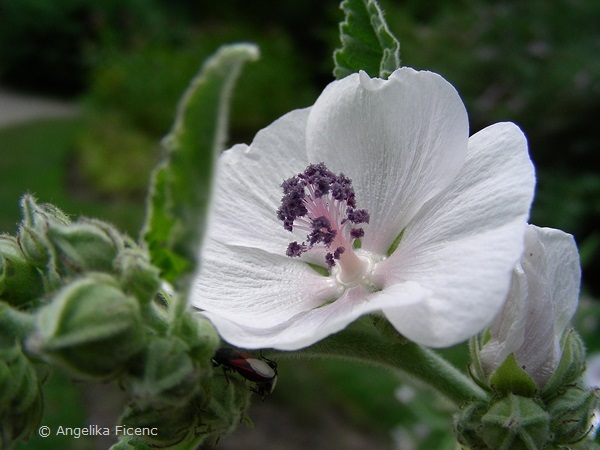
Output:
top-left (212, 347), bottom-right (277, 401)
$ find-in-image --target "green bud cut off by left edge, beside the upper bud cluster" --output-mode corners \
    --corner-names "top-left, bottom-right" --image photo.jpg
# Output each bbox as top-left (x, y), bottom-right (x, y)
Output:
top-left (0, 235), bottom-right (44, 306)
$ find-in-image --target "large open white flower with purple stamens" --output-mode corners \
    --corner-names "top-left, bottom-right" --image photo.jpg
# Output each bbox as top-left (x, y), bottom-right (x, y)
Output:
top-left (190, 68), bottom-right (535, 350)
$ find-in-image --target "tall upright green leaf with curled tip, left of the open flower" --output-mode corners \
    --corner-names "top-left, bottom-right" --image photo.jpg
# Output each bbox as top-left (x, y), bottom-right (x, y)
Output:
top-left (142, 44), bottom-right (258, 287)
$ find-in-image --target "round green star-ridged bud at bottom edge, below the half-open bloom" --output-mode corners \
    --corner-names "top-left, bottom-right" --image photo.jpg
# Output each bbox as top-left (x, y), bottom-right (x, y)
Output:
top-left (481, 394), bottom-right (552, 450)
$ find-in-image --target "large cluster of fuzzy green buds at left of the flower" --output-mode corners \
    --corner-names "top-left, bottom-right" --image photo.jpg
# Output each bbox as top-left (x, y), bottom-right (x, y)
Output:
top-left (0, 196), bottom-right (249, 448)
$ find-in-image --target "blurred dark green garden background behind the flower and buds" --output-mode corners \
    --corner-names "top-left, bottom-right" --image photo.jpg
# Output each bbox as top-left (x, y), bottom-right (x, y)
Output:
top-left (0, 0), bottom-right (600, 449)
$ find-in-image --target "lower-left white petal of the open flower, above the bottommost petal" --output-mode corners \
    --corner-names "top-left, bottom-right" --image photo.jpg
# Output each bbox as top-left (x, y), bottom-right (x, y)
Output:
top-left (190, 239), bottom-right (340, 327)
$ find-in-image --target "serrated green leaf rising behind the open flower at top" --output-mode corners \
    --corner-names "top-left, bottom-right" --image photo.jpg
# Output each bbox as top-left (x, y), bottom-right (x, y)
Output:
top-left (333, 0), bottom-right (400, 80)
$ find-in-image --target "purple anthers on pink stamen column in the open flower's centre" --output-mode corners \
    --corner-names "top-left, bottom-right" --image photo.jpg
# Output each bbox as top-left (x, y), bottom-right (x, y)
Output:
top-left (277, 163), bottom-right (369, 283)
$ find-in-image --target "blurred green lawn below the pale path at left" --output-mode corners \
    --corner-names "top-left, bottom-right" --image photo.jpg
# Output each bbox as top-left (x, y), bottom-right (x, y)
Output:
top-left (0, 119), bottom-right (144, 236)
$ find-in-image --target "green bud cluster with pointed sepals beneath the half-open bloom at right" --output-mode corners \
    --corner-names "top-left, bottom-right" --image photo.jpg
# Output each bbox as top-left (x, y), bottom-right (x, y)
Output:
top-left (454, 330), bottom-right (600, 450)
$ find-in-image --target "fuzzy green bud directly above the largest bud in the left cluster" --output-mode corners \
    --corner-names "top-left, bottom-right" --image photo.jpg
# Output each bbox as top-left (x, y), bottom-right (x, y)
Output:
top-left (47, 220), bottom-right (122, 276)
